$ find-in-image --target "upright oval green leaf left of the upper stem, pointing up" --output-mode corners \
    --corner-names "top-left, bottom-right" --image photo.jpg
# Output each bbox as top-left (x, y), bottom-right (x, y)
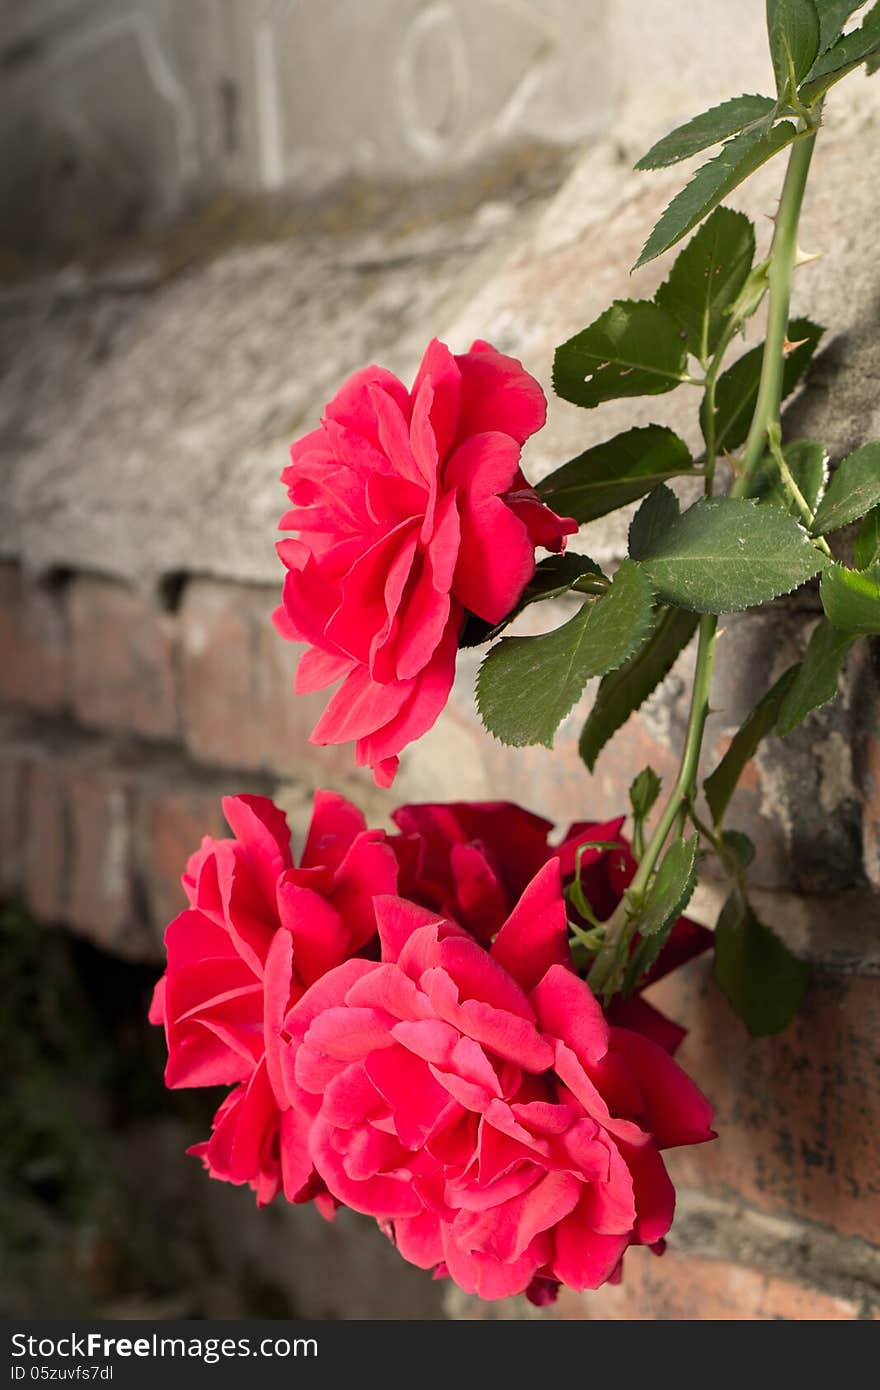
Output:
top-left (655, 207), bottom-right (755, 363)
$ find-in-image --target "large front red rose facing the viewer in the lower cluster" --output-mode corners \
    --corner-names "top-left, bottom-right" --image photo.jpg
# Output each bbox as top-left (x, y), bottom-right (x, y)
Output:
top-left (281, 856), bottom-right (713, 1301)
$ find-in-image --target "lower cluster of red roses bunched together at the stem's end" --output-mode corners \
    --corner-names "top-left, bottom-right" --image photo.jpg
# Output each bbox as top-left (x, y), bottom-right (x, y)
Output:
top-left (150, 792), bottom-right (712, 1302)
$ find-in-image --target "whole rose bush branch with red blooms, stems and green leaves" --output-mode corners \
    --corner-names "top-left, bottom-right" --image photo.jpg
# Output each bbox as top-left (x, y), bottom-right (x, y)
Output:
top-left (147, 0), bottom-right (880, 1302)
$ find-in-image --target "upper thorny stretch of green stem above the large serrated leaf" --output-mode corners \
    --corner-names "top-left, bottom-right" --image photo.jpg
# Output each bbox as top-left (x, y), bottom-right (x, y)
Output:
top-left (730, 131), bottom-right (816, 498)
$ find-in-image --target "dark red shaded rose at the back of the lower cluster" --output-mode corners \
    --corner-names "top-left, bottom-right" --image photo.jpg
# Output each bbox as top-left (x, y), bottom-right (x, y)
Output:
top-left (392, 801), bottom-right (712, 1054)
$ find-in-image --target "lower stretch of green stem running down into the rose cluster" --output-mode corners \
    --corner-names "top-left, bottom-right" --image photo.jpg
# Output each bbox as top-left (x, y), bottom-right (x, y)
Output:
top-left (589, 614), bottom-right (717, 994)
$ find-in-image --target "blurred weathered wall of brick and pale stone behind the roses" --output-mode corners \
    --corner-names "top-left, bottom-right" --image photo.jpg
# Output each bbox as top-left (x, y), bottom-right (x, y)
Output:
top-left (0, 0), bottom-right (880, 1319)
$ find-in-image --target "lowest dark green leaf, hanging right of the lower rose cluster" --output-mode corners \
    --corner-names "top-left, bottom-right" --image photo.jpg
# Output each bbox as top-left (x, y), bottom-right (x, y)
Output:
top-left (715, 887), bottom-right (812, 1037)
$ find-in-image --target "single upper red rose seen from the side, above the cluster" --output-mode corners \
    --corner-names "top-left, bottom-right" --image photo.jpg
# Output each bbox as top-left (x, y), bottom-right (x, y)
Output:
top-left (275, 339), bottom-right (577, 787)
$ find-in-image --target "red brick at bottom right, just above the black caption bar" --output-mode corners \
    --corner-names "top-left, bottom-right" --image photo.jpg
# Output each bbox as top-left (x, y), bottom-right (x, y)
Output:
top-left (551, 1250), bottom-right (869, 1322)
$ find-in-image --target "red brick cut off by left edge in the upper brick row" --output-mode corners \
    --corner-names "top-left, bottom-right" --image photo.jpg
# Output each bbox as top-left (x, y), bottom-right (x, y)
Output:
top-left (0, 564), bottom-right (68, 712)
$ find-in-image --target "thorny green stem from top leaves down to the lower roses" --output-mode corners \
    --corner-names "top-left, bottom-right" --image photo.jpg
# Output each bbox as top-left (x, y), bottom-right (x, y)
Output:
top-left (588, 129), bottom-right (816, 998)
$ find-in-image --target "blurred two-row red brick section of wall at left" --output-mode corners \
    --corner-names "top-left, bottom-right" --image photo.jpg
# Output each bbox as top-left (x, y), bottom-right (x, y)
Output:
top-left (0, 564), bottom-right (330, 960)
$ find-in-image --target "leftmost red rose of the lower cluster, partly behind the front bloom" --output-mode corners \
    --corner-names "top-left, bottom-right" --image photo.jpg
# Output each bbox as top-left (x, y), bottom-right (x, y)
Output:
top-left (150, 792), bottom-right (398, 1212)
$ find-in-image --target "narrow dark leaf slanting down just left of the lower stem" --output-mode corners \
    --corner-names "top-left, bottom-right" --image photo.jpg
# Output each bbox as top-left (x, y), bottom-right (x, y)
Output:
top-left (578, 607), bottom-right (698, 771)
